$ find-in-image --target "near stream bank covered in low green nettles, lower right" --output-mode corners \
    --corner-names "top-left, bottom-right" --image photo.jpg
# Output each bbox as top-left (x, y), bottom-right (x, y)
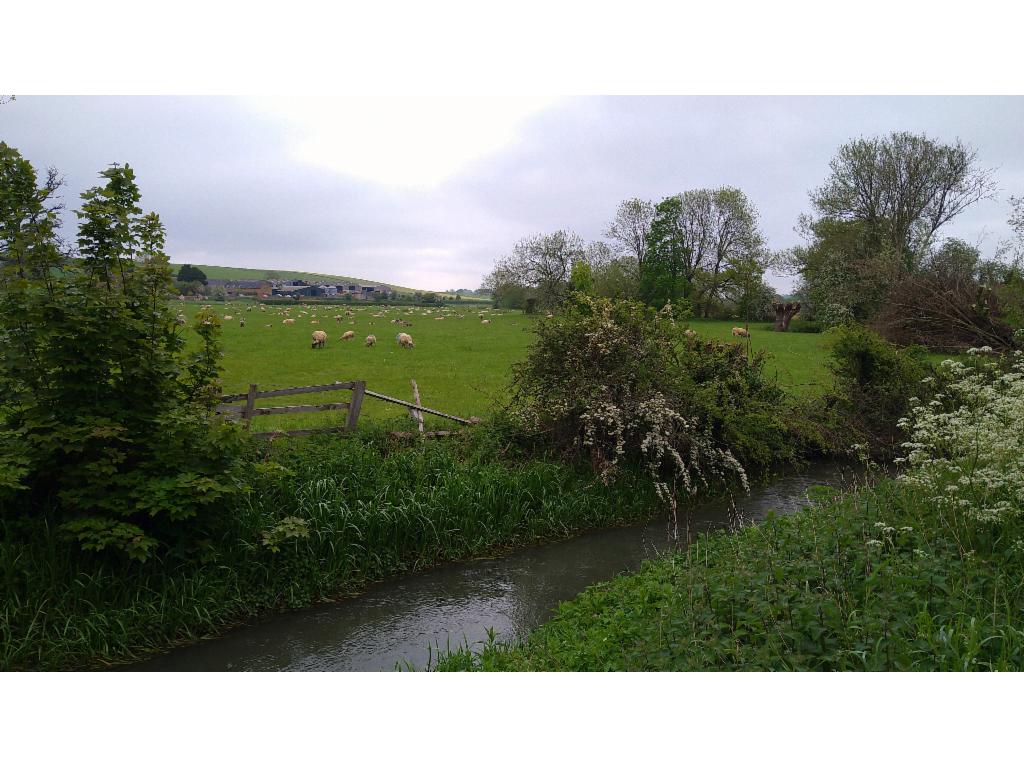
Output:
top-left (434, 468), bottom-right (1024, 671)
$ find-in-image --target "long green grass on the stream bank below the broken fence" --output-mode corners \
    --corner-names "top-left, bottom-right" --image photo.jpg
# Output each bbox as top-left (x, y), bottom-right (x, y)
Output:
top-left (0, 430), bottom-right (653, 670)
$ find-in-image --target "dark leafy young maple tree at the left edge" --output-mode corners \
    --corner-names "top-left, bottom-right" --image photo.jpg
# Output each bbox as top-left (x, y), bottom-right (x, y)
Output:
top-left (0, 145), bottom-right (241, 559)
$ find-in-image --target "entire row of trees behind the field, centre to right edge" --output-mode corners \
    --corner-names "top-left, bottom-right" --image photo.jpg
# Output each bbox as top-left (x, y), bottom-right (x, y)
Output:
top-left (483, 132), bottom-right (1024, 347)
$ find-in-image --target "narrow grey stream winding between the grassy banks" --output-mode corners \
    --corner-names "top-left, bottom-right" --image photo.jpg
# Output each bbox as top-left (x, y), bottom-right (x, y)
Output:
top-left (121, 463), bottom-right (854, 672)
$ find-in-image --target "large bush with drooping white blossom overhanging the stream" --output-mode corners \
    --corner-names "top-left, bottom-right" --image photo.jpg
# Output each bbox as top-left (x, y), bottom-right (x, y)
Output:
top-left (509, 294), bottom-right (787, 537)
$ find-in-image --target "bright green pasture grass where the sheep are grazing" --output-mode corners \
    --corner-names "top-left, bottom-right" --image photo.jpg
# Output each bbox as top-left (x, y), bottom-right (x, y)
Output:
top-left (179, 302), bottom-right (827, 431)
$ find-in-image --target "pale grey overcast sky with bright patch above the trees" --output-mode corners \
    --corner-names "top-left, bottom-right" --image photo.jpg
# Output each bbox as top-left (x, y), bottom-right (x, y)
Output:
top-left (0, 94), bottom-right (1024, 291)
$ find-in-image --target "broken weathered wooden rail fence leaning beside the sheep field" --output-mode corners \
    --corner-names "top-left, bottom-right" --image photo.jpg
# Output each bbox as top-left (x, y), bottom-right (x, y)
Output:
top-left (217, 381), bottom-right (479, 437)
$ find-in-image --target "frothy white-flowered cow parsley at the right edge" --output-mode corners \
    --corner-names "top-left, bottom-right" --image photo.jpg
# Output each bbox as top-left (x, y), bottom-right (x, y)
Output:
top-left (897, 346), bottom-right (1024, 523)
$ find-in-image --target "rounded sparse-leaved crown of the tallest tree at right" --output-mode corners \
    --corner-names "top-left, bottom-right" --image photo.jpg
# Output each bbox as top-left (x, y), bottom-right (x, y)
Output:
top-left (811, 132), bottom-right (994, 271)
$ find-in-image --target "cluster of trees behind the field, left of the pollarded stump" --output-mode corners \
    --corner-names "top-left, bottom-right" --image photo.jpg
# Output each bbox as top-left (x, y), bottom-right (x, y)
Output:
top-left (483, 186), bottom-right (775, 318)
